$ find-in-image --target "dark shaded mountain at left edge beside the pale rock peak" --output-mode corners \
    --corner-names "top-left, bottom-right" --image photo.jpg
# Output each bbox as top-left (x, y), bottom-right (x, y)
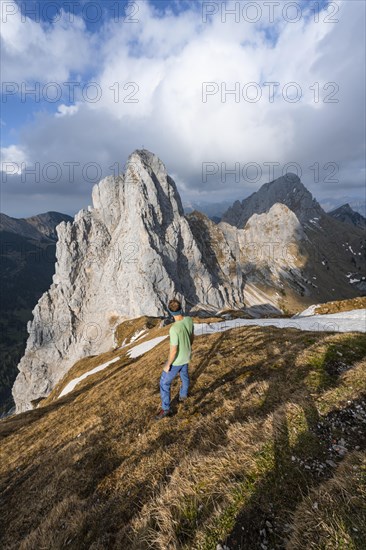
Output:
top-left (0, 212), bottom-right (72, 413)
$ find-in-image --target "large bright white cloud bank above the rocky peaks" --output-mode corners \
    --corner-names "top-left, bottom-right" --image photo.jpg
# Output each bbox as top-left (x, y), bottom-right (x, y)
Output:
top-left (1, 0), bottom-right (365, 216)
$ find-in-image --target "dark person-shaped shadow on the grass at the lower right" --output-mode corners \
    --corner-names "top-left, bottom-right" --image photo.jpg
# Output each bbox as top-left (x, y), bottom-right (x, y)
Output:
top-left (225, 396), bottom-right (366, 550)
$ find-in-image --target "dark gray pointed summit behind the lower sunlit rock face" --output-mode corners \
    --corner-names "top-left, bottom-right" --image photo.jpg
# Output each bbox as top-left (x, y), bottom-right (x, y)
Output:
top-left (221, 176), bottom-right (324, 229)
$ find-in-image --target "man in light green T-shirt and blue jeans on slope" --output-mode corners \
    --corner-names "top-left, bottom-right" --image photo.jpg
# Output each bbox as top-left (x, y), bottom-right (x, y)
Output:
top-left (156, 300), bottom-right (194, 420)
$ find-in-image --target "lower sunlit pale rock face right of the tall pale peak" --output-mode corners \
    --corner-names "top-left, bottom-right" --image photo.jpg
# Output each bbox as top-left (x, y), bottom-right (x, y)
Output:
top-left (187, 203), bottom-right (307, 316)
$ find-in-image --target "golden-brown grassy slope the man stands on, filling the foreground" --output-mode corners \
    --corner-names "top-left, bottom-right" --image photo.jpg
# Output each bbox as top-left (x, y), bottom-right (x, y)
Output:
top-left (0, 320), bottom-right (366, 550)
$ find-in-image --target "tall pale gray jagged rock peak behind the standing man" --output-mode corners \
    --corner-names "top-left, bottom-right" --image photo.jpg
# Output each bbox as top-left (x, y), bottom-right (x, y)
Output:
top-left (13, 150), bottom-right (243, 411)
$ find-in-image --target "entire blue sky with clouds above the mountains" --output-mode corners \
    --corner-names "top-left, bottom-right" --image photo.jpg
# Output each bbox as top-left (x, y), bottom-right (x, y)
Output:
top-left (1, 0), bottom-right (365, 216)
